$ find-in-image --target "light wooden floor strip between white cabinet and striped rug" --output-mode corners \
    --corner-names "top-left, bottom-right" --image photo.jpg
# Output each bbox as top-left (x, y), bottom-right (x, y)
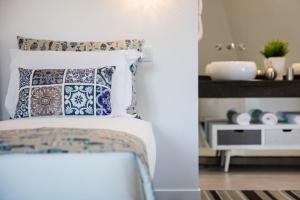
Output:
top-left (200, 166), bottom-right (300, 190)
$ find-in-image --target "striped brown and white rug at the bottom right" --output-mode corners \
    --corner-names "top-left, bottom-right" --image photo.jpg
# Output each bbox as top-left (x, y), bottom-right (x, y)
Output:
top-left (201, 190), bottom-right (300, 200)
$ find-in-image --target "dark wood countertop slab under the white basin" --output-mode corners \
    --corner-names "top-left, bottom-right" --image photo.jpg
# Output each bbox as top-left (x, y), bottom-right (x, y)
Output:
top-left (198, 76), bottom-right (300, 98)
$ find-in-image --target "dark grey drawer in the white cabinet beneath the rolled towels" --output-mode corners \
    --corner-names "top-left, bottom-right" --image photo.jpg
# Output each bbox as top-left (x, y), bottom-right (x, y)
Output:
top-left (217, 130), bottom-right (261, 145)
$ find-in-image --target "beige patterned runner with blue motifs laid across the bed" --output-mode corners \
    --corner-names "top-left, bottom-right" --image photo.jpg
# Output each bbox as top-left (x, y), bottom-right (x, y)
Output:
top-left (0, 128), bottom-right (148, 169)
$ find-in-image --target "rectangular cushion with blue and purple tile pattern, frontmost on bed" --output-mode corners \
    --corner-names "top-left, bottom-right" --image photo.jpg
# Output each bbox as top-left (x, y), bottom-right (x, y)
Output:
top-left (15, 66), bottom-right (115, 118)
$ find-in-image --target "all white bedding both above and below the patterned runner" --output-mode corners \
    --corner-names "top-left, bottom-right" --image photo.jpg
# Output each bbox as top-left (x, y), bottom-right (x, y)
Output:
top-left (0, 117), bottom-right (156, 200)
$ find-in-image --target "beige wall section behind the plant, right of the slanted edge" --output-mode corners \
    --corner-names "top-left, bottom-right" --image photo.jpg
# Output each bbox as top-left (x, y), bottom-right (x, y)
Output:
top-left (222, 0), bottom-right (300, 66)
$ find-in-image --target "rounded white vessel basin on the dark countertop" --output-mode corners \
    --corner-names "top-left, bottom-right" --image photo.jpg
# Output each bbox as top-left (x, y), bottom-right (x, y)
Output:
top-left (206, 61), bottom-right (256, 80)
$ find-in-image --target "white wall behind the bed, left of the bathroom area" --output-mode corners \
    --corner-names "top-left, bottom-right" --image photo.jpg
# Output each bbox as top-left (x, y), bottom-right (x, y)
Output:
top-left (0, 0), bottom-right (199, 199)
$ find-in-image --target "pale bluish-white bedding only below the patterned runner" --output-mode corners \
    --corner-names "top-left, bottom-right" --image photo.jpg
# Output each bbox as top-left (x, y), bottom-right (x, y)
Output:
top-left (0, 153), bottom-right (145, 200)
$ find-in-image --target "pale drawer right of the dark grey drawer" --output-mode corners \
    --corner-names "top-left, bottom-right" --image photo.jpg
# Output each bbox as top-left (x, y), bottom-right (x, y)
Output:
top-left (265, 129), bottom-right (300, 146)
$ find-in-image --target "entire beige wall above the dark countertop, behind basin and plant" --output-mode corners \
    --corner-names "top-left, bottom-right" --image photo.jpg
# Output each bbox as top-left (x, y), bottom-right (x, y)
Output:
top-left (199, 0), bottom-right (300, 70)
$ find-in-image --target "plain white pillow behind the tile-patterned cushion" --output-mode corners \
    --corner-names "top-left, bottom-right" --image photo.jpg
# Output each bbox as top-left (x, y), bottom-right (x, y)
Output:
top-left (5, 49), bottom-right (140, 117)
